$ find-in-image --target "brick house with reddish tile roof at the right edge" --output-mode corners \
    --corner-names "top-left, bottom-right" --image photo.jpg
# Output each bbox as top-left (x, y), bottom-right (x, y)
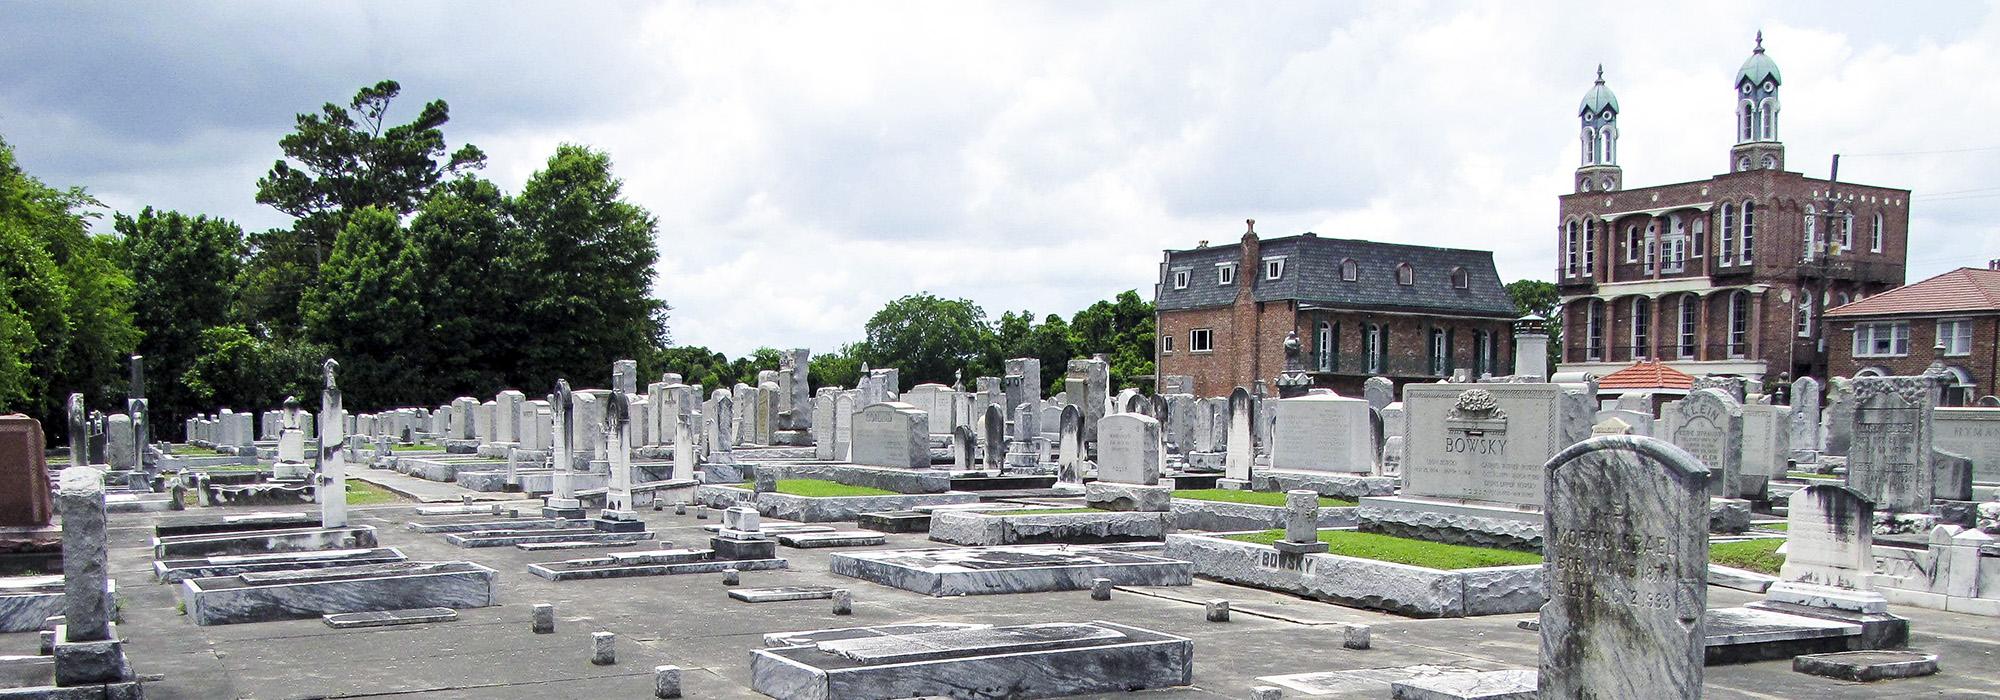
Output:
top-left (1826, 260), bottom-right (2000, 406)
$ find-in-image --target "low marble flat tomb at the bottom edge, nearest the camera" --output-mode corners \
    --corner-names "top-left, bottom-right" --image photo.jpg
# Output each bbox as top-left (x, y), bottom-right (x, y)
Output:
top-left (750, 622), bottom-right (1194, 700)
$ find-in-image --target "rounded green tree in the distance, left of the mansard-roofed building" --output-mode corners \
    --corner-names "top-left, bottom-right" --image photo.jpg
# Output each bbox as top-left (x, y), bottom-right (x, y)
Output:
top-left (866, 294), bottom-right (986, 390)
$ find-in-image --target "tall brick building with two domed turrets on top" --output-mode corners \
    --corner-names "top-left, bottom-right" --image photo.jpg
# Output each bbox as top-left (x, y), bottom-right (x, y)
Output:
top-left (1556, 34), bottom-right (1910, 388)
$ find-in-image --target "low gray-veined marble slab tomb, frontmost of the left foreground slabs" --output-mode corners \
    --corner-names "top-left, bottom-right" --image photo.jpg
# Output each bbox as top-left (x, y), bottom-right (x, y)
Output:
top-left (180, 562), bottom-right (498, 626)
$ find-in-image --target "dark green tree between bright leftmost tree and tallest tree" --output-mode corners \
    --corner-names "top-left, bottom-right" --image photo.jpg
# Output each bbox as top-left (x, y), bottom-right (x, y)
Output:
top-left (112, 206), bottom-right (244, 426)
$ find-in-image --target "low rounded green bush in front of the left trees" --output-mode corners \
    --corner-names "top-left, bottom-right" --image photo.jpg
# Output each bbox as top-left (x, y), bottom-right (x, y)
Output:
top-left (184, 326), bottom-right (320, 410)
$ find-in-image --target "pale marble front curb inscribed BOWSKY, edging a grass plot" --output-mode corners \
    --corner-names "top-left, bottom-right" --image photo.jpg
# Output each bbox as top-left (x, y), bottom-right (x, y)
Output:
top-left (1166, 534), bottom-right (1542, 618)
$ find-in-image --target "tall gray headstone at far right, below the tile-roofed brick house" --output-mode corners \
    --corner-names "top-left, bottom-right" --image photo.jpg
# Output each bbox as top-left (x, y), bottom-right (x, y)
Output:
top-left (1848, 376), bottom-right (1938, 512)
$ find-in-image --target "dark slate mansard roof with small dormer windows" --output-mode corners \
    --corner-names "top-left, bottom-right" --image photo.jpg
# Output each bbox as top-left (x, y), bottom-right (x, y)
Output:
top-left (1154, 232), bottom-right (1518, 318)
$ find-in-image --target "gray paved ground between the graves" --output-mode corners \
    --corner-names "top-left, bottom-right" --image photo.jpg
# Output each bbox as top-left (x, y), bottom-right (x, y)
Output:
top-left (15, 486), bottom-right (2000, 700)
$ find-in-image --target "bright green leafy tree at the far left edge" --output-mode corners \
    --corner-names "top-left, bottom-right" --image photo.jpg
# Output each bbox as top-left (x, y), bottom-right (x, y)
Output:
top-left (0, 142), bottom-right (140, 438)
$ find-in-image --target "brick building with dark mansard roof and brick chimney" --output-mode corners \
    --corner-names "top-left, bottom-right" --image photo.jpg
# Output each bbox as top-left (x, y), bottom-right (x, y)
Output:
top-left (1154, 222), bottom-right (1516, 396)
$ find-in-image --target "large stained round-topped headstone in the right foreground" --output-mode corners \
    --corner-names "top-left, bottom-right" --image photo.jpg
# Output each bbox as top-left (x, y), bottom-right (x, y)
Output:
top-left (1540, 436), bottom-right (1710, 698)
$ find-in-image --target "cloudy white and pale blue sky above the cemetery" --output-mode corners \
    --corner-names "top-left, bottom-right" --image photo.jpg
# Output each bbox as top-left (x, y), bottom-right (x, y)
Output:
top-left (0, 0), bottom-right (2000, 354)
